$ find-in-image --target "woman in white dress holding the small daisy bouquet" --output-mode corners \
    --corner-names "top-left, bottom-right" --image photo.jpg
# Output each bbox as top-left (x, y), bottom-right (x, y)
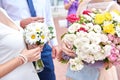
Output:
top-left (0, 8), bottom-right (42, 80)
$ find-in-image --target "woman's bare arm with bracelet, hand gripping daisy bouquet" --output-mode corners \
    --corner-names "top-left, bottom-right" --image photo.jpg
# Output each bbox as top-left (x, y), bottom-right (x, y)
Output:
top-left (0, 47), bottom-right (42, 78)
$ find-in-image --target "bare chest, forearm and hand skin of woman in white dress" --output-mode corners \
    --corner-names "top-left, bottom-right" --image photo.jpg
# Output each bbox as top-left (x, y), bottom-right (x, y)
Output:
top-left (0, 11), bottom-right (42, 78)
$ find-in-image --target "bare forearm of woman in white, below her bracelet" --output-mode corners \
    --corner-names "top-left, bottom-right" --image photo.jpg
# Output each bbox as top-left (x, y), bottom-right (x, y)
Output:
top-left (0, 57), bottom-right (24, 78)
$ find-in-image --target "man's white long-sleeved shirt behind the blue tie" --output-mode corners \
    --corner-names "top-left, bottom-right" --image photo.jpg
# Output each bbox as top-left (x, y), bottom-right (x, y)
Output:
top-left (0, 0), bottom-right (58, 46)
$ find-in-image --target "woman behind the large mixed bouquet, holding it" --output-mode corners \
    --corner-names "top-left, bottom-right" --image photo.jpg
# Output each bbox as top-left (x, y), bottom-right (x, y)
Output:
top-left (62, 0), bottom-right (120, 80)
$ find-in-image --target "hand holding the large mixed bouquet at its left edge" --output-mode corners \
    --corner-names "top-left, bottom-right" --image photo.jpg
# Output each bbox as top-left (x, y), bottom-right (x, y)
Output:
top-left (61, 41), bottom-right (76, 57)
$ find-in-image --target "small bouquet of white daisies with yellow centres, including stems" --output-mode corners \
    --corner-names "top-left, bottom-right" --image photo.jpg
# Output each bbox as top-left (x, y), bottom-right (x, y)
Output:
top-left (24, 22), bottom-right (55, 72)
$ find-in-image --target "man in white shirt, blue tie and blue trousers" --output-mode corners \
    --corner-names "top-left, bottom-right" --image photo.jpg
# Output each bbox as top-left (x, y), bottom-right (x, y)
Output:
top-left (0, 0), bottom-right (59, 80)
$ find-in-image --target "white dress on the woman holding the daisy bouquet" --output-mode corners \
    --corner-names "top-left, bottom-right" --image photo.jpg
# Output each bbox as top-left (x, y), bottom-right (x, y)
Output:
top-left (0, 8), bottom-right (40, 80)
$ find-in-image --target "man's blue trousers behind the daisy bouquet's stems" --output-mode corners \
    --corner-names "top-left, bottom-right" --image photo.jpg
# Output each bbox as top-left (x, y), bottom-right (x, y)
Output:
top-left (38, 44), bottom-right (56, 80)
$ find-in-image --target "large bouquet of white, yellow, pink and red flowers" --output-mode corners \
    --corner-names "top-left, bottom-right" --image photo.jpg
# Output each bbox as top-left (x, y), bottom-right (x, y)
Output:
top-left (62, 9), bottom-right (120, 71)
